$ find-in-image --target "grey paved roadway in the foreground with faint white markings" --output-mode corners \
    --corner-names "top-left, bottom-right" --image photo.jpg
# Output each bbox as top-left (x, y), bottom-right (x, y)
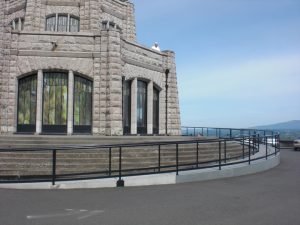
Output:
top-left (0, 149), bottom-right (300, 225)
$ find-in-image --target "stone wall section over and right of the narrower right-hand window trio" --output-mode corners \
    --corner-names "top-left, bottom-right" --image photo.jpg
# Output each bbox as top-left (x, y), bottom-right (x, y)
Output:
top-left (122, 40), bottom-right (181, 135)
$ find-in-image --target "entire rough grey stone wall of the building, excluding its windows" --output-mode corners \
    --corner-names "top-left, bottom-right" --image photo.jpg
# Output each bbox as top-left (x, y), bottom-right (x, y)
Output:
top-left (0, 0), bottom-right (180, 135)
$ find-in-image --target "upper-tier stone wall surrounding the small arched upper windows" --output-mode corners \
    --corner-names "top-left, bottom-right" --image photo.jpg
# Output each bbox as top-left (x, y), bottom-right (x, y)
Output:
top-left (21, 0), bottom-right (136, 41)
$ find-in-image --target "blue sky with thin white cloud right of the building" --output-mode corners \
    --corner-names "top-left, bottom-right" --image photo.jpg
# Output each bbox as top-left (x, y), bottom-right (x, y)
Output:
top-left (132, 0), bottom-right (300, 127)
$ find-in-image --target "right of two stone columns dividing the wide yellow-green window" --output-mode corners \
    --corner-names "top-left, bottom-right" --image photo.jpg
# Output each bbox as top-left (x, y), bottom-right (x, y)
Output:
top-left (68, 70), bottom-right (74, 135)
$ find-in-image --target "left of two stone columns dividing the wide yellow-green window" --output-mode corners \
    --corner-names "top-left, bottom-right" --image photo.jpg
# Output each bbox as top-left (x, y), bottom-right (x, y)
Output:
top-left (35, 70), bottom-right (43, 134)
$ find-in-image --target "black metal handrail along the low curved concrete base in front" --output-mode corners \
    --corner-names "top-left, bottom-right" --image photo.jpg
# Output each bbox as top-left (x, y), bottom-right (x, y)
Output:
top-left (0, 127), bottom-right (280, 186)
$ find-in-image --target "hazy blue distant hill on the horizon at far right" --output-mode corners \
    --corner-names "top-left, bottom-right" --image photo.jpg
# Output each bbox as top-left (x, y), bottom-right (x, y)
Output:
top-left (253, 120), bottom-right (300, 140)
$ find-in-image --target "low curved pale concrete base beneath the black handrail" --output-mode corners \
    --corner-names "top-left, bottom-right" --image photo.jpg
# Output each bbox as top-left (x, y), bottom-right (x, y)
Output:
top-left (0, 150), bottom-right (280, 189)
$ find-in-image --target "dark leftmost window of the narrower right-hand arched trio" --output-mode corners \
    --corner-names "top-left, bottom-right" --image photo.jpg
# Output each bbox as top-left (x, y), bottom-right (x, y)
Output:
top-left (123, 81), bottom-right (131, 134)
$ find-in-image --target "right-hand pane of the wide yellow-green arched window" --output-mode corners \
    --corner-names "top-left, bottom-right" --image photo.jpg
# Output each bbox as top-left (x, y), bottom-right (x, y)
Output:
top-left (74, 76), bottom-right (92, 133)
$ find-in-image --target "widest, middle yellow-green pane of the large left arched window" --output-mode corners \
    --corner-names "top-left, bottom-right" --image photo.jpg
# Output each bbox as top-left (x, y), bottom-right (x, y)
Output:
top-left (43, 73), bottom-right (68, 133)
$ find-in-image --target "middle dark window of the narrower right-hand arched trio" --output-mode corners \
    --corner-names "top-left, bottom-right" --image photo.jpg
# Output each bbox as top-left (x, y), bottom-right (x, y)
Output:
top-left (137, 80), bottom-right (147, 134)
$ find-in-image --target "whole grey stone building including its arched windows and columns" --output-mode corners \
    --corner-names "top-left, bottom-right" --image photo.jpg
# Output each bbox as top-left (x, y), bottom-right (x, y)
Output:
top-left (0, 0), bottom-right (180, 135)
